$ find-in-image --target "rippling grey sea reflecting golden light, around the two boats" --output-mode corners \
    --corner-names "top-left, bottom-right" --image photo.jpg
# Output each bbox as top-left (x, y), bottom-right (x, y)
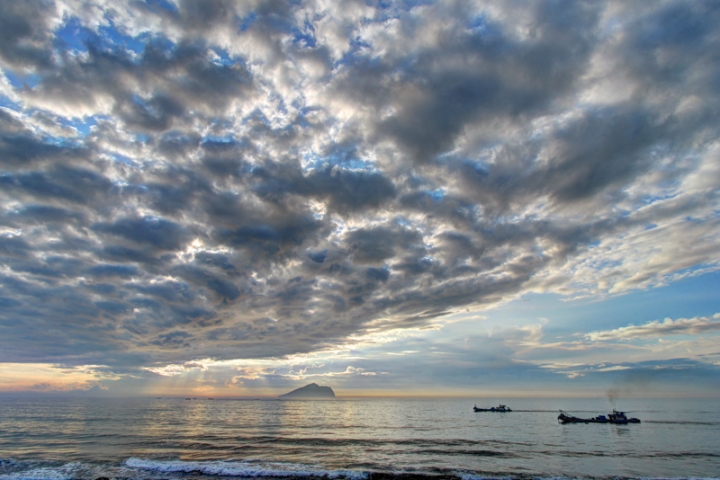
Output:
top-left (0, 396), bottom-right (720, 480)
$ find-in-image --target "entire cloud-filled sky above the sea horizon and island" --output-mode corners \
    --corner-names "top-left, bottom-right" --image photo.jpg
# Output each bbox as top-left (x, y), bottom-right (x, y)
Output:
top-left (0, 0), bottom-right (720, 397)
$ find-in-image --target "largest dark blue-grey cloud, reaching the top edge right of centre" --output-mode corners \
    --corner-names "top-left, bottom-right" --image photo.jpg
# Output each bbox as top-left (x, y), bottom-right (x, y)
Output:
top-left (338, 2), bottom-right (600, 162)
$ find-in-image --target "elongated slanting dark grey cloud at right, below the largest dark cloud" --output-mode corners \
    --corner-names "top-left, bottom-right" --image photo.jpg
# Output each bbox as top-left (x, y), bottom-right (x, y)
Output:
top-left (453, 104), bottom-right (684, 211)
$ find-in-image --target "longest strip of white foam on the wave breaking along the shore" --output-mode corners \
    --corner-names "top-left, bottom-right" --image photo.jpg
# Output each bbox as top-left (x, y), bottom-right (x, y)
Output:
top-left (125, 457), bottom-right (368, 480)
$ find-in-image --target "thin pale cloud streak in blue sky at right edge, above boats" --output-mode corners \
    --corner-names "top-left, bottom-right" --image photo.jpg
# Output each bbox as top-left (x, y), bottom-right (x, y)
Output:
top-left (586, 313), bottom-right (720, 341)
